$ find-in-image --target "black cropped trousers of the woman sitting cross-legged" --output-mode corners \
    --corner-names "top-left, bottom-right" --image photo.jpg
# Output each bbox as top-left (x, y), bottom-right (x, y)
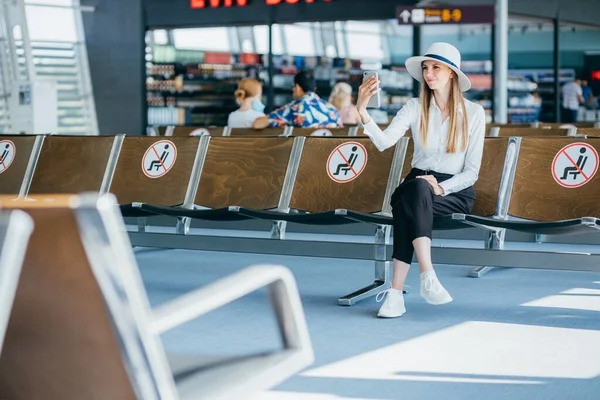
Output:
top-left (391, 168), bottom-right (475, 264)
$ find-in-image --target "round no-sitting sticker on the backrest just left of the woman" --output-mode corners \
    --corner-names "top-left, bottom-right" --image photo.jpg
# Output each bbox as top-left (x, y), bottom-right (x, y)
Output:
top-left (327, 142), bottom-right (367, 183)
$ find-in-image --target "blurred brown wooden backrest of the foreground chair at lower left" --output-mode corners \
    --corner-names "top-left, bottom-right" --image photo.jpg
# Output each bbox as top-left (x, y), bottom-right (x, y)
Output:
top-left (0, 197), bottom-right (136, 400)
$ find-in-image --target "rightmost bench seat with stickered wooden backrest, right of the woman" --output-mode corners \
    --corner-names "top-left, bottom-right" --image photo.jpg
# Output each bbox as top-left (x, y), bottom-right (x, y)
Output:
top-left (460, 138), bottom-right (600, 235)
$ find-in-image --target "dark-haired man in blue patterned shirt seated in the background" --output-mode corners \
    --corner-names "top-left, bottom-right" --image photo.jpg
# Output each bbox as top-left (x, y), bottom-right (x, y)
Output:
top-left (252, 71), bottom-right (342, 129)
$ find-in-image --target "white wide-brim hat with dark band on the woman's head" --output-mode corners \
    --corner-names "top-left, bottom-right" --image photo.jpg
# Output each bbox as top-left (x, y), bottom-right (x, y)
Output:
top-left (405, 42), bottom-right (471, 92)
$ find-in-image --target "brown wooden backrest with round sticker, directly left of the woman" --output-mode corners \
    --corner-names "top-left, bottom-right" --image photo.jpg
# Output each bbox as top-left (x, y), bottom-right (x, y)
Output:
top-left (290, 137), bottom-right (394, 213)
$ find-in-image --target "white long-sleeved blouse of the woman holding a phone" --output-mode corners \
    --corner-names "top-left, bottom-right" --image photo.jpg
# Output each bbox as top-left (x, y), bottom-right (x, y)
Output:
top-left (365, 98), bottom-right (485, 196)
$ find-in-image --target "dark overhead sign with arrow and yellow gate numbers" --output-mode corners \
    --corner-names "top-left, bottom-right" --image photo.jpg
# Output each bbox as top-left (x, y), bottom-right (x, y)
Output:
top-left (396, 5), bottom-right (495, 25)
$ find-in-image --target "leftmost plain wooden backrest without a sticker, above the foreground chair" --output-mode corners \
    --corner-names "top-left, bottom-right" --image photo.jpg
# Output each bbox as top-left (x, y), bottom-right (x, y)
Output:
top-left (29, 136), bottom-right (115, 194)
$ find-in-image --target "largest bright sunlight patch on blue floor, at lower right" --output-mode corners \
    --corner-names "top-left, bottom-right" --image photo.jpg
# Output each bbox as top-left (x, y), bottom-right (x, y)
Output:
top-left (302, 320), bottom-right (600, 384)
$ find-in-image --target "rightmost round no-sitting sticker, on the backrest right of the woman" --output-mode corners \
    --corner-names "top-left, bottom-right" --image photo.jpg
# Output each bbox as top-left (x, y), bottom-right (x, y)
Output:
top-left (552, 143), bottom-right (598, 189)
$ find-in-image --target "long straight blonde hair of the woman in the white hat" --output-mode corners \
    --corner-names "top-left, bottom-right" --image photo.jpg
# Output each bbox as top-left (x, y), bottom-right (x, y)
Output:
top-left (419, 74), bottom-right (469, 153)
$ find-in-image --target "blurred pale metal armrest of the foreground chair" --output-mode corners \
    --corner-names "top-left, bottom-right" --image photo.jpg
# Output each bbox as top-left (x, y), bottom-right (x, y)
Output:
top-left (152, 265), bottom-right (312, 353)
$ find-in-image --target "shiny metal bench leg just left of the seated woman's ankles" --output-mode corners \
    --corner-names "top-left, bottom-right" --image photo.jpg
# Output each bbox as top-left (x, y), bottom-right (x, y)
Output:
top-left (338, 225), bottom-right (400, 306)
